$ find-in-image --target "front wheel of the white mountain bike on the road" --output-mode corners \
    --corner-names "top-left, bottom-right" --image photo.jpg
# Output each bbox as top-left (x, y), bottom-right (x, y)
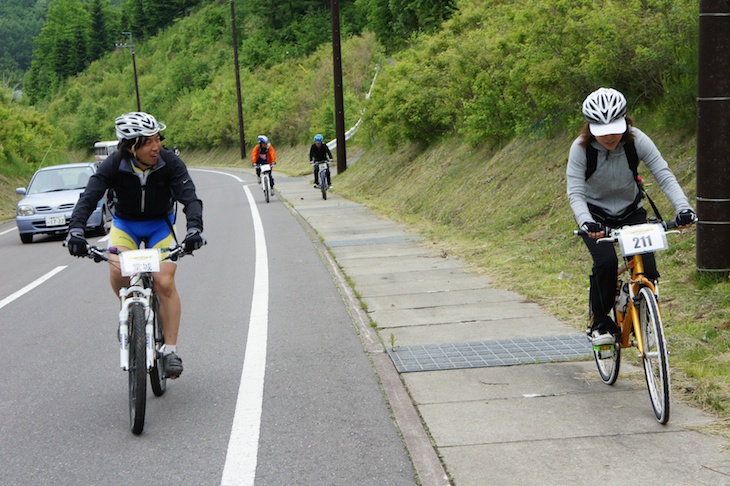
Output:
top-left (129, 304), bottom-right (147, 435)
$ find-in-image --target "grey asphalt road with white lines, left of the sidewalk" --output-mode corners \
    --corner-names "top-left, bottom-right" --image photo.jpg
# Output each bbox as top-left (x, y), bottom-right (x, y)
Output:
top-left (0, 170), bottom-right (416, 486)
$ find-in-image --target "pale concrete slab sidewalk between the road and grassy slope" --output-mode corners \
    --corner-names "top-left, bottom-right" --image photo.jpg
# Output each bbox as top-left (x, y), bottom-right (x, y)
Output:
top-left (272, 174), bottom-right (730, 486)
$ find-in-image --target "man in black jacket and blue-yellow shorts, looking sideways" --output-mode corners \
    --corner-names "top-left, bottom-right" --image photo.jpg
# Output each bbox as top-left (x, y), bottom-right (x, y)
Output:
top-left (66, 112), bottom-right (205, 378)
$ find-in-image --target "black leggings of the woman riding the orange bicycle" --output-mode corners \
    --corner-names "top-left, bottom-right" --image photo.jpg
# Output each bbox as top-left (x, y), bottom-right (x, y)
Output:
top-left (583, 208), bottom-right (659, 329)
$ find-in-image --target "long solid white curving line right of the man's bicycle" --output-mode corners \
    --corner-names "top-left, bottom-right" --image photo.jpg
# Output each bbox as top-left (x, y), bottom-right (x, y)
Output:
top-left (221, 186), bottom-right (269, 486)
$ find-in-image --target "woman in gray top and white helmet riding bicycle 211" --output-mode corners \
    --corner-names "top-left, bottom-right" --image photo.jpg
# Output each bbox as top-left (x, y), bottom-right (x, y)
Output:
top-left (567, 88), bottom-right (696, 345)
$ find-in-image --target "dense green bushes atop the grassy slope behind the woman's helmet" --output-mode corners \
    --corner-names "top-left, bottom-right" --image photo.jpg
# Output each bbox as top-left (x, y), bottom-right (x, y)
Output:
top-left (368, 0), bottom-right (698, 145)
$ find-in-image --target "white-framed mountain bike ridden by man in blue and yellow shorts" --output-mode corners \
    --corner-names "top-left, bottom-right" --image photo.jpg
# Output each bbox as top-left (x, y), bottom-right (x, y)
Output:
top-left (87, 245), bottom-right (186, 435)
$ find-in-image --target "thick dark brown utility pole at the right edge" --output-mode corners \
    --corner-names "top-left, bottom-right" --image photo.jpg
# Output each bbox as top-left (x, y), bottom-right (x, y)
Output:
top-left (696, 0), bottom-right (730, 273)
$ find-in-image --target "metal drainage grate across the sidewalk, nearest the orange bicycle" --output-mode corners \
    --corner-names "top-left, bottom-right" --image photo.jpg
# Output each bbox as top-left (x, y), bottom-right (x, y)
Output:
top-left (387, 334), bottom-right (592, 373)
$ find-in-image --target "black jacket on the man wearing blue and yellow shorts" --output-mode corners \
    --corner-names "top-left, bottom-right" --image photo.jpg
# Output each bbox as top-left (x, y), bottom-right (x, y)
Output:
top-left (69, 149), bottom-right (203, 231)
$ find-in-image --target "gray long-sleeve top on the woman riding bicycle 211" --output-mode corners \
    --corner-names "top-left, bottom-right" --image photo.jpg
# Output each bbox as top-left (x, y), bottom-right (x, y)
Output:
top-left (566, 127), bottom-right (692, 226)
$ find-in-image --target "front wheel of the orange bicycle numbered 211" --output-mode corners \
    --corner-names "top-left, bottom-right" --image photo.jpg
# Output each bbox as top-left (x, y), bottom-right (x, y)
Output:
top-left (639, 287), bottom-right (670, 424)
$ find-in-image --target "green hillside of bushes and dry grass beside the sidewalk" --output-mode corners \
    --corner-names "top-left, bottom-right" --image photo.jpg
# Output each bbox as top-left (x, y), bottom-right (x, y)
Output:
top-left (0, 0), bottom-right (730, 416)
